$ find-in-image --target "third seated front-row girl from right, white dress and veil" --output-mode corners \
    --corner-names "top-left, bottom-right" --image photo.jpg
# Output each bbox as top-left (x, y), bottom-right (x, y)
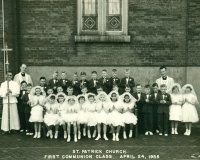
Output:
top-left (95, 91), bottom-right (109, 141)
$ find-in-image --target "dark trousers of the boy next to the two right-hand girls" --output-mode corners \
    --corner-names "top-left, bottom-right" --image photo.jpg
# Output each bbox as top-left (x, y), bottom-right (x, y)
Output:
top-left (158, 113), bottom-right (169, 134)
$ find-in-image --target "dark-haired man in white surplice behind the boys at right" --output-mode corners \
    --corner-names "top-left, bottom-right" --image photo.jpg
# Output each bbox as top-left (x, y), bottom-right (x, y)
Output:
top-left (156, 66), bottom-right (174, 93)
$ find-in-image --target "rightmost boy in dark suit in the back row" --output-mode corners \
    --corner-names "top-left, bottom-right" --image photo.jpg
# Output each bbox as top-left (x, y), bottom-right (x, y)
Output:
top-left (120, 69), bottom-right (135, 94)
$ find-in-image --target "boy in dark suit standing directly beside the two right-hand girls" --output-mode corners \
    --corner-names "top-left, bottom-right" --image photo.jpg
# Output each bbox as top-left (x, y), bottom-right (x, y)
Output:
top-left (156, 84), bottom-right (172, 136)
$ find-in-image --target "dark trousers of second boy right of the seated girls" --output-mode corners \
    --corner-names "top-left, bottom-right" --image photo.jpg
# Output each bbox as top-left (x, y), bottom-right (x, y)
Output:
top-left (144, 113), bottom-right (153, 132)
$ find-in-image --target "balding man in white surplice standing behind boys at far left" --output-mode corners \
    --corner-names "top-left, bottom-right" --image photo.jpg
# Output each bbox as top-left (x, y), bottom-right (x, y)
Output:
top-left (14, 64), bottom-right (33, 86)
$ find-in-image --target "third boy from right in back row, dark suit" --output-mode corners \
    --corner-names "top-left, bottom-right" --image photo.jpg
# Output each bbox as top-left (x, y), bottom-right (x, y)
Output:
top-left (99, 69), bottom-right (111, 94)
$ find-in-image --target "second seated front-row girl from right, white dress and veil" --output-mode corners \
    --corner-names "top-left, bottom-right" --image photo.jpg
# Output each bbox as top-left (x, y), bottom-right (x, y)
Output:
top-left (108, 90), bottom-right (124, 141)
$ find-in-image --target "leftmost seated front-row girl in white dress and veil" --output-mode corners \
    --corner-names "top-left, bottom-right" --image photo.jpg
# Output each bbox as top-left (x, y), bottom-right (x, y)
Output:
top-left (44, 94), bottom-right (58, 139)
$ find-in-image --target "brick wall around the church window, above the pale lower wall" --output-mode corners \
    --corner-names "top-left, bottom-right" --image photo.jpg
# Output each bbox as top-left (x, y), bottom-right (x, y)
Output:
top-left (16, 0), bottom-right (187, 66)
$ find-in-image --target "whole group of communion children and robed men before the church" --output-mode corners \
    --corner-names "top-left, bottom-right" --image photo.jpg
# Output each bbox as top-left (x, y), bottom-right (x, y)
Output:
top-left (0, 64), bottom-right (199, 142)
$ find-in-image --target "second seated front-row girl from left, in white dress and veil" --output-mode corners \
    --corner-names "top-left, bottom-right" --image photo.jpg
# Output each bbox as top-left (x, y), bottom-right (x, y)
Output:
top-left (55, 93), bottom-right (67, 139)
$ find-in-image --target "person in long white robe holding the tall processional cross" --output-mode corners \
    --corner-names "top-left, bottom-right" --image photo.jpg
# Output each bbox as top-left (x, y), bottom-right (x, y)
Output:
top-left (0, 72), bottom-right (20, 132)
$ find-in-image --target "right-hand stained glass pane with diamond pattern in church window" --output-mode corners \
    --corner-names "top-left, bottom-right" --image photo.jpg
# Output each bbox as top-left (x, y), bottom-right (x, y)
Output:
top-left (106, 0), bottom-right (122, 31)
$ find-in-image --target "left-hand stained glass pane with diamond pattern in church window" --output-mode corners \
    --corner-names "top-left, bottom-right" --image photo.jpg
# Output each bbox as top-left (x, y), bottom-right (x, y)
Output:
top-left (82, 0), bottom-right (98, 31)
